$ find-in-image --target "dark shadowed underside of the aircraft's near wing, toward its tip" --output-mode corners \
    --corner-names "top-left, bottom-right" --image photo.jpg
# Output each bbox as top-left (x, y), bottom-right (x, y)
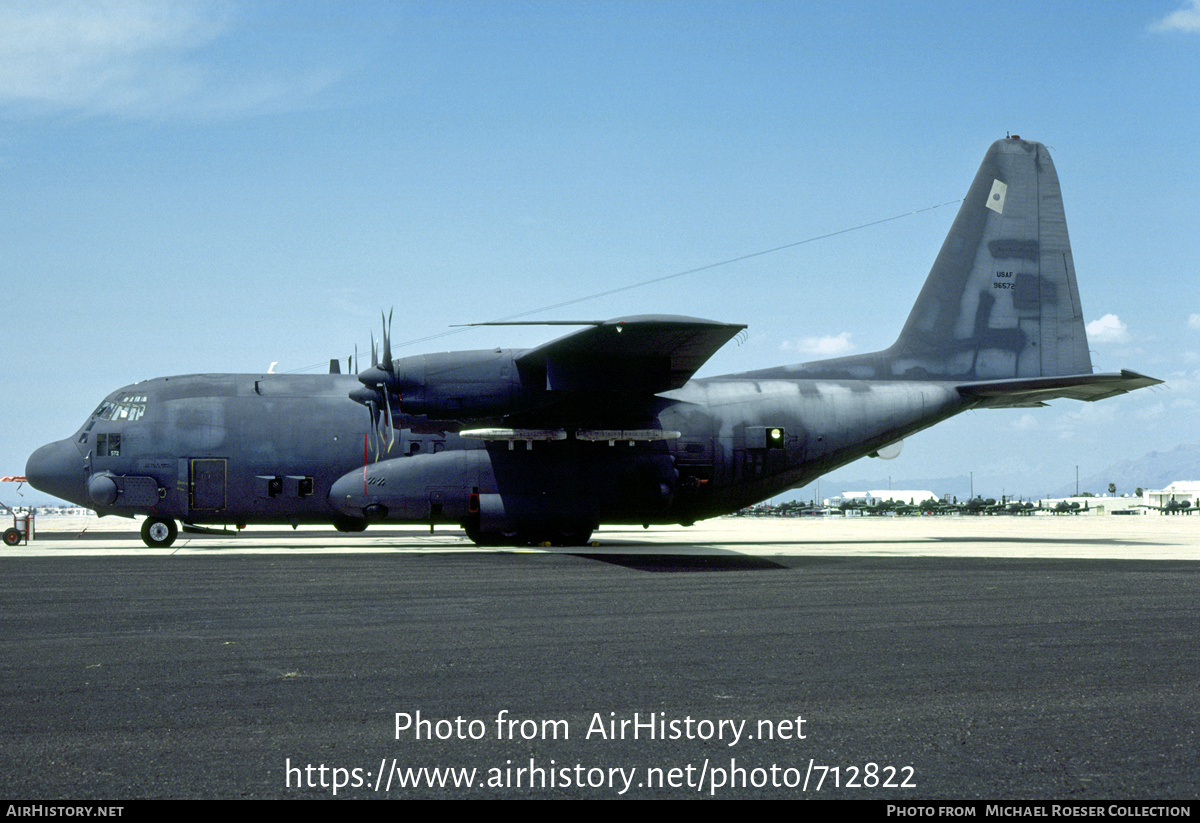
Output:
top-left (516, 314), bottom-right (745, 395)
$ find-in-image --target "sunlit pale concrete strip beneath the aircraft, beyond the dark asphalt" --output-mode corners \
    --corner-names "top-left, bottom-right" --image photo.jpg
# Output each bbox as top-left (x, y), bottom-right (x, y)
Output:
top-left (0, 515), bottom-right (1200, 560)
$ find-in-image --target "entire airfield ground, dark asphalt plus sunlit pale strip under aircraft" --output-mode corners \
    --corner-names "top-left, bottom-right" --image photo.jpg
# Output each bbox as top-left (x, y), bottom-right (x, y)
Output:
top-left (0, 517), bottom-right (1200, 801)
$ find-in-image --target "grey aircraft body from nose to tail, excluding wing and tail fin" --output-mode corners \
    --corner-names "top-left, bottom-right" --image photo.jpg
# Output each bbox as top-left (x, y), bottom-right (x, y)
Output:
top-left (26, 373), bottom-right (967, 533)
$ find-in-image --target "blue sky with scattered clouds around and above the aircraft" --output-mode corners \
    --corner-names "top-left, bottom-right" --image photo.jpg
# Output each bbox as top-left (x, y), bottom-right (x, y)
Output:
top-left (0, 0), bottom-right (1200, 503)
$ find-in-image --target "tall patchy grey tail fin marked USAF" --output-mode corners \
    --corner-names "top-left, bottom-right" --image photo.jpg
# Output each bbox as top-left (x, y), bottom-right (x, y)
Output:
top-left (881, 137), bottom-right (1092, 380)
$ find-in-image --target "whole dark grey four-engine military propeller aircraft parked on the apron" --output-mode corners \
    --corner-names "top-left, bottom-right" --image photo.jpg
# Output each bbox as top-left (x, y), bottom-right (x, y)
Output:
top-left (25, 137), bottom-right (1159, 546)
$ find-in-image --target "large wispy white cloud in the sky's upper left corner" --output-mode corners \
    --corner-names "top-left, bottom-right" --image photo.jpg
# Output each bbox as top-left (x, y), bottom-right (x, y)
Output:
top-left (0, 0), bottom-right (331, 118)
